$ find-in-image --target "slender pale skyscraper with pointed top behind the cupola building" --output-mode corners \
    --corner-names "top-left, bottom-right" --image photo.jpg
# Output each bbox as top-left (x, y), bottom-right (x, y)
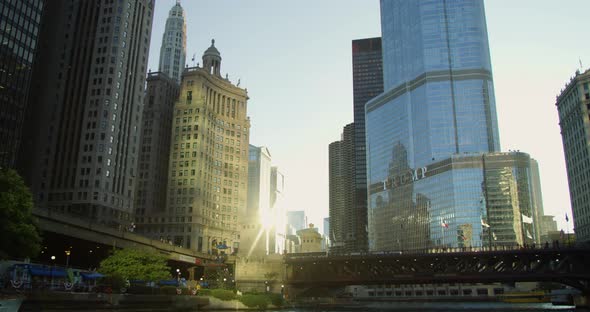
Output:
top-left (159, 0), bottom-right (186, 84)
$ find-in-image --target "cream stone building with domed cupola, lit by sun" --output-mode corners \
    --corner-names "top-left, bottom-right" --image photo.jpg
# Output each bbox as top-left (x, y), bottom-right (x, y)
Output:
top-left (143, 41), bottom-right (250, 254)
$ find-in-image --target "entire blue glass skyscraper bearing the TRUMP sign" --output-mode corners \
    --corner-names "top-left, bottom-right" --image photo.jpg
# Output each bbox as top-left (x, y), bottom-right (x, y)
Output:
top-left (365, 0), bottom-right (538, 251)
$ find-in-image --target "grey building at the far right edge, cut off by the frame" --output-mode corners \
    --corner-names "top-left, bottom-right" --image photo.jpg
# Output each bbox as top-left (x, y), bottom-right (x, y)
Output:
top-left (556, 70), bottom-right (590, 242)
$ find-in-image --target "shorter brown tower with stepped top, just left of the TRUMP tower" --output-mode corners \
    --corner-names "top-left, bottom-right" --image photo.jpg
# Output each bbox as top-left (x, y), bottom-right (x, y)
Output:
top-left (329, 123), bottom-right (367, 253)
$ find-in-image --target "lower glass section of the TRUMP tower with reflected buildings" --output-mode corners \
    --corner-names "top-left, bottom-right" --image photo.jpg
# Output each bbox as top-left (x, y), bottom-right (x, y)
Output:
top-left (369, 152), bottom-right (538, 251)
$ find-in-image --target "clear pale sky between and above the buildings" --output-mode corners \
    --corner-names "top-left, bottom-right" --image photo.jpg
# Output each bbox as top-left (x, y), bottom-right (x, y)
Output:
top-left (149, 0), bottom-right (590, 231)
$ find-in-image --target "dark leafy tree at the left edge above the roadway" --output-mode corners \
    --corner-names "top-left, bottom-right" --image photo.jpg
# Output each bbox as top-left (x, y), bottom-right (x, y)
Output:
top-left (0, 169), bottom-right (41, 259)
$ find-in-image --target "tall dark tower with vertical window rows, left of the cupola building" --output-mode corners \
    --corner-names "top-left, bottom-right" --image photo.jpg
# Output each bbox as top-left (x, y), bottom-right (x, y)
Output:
top-left (31, 0), bottom-right (154, 226)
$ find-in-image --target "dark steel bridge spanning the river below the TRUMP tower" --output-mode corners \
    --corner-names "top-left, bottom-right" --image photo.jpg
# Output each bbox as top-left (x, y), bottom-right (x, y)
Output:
top-left (284, 247), bottom-right (590, 293)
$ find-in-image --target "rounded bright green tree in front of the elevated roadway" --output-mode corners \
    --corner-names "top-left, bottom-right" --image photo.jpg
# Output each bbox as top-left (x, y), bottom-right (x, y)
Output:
top-left (98, 248), bottom-right (171, 281)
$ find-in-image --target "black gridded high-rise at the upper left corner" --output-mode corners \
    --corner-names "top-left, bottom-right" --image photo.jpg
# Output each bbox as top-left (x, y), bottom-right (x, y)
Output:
top-left (0, 0), bottom-right (45, 169)
